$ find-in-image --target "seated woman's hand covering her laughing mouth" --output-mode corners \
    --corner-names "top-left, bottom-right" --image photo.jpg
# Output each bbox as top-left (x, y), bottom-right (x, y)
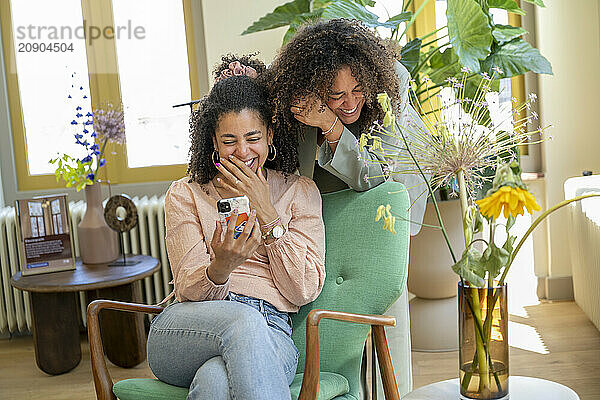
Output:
top-left (217, 156), bottom-right (278, 225)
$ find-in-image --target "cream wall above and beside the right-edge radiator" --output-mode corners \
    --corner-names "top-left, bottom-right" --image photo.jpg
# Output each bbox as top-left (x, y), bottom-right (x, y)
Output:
top-left (536, 0), bottom-right (600, 277)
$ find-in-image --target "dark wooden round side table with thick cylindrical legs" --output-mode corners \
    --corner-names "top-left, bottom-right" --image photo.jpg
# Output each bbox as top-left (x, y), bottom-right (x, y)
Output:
top-left (11, 255), bottom-right (160, 375)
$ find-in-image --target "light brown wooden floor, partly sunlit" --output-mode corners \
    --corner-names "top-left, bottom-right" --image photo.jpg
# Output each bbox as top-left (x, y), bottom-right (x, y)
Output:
top-left (0, 302), bottom-right (600, 400)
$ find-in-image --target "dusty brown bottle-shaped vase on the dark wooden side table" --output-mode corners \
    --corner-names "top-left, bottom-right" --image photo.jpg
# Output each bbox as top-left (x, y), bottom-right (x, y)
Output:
top-left (77, 182), bottom-right (119, 264)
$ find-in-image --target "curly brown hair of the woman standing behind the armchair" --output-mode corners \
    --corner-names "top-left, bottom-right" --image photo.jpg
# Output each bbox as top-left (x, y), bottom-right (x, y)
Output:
top-left (261, 19), bottom-right (400, 142)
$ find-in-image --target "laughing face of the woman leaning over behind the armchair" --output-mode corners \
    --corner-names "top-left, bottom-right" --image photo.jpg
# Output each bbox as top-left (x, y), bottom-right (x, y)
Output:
top-left (327, 66), bottom-right (365, 125)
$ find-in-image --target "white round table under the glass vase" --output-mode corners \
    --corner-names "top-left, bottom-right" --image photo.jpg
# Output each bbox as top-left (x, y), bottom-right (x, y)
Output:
top-left (402, 376), bottom-right (579, 400)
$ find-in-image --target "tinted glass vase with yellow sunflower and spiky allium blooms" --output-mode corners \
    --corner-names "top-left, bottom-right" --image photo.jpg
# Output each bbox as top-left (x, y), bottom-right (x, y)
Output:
top-left (359, 68), bottom-right (600, 399)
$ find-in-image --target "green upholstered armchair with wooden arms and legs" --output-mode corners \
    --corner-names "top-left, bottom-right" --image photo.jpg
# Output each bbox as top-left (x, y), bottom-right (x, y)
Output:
top-left (87, 182), bottom-right (410, 400)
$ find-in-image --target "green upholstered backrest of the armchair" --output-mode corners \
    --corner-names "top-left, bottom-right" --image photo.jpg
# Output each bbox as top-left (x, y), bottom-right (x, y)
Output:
top-left (292, 182), bottom-right (410, 399)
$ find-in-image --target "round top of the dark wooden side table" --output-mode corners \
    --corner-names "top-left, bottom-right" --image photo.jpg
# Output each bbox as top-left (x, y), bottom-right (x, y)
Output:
top-left (10, 254), bottom-right (160, 293)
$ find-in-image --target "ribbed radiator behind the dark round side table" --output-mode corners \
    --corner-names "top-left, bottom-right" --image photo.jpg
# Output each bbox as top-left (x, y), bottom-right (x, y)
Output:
top-left (0, 196), bottom-right (172, 334)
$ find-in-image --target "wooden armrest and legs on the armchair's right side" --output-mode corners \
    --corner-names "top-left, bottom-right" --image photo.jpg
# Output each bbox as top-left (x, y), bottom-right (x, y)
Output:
top-left (298, 310), bottom-right (400, 400)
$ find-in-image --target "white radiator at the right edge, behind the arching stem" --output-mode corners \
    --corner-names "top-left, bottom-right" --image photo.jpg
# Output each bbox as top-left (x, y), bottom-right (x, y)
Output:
top-left (565, 175), bottom-right (600, 330)
